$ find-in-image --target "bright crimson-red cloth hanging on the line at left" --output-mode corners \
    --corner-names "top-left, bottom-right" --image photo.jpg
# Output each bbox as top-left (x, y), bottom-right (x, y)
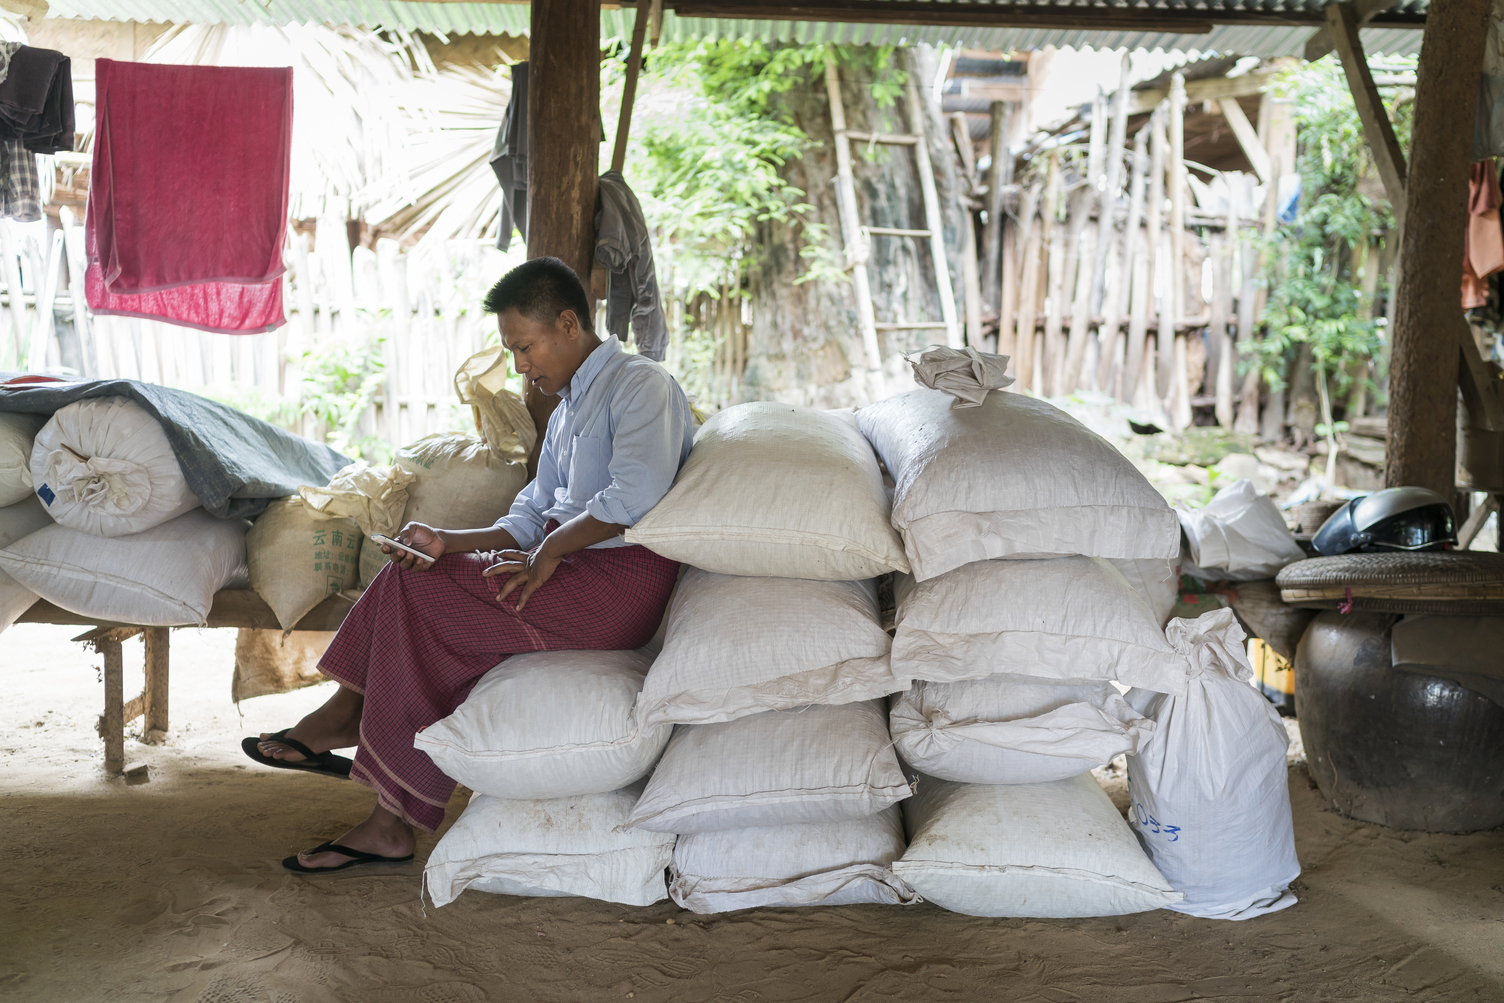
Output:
top-left (84, 59), bottom-right (292, 334)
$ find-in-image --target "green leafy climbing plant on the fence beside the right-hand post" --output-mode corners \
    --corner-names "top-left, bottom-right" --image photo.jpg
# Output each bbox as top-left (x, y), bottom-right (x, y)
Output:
top-left (1257, 59), bottom-right (1411, 392)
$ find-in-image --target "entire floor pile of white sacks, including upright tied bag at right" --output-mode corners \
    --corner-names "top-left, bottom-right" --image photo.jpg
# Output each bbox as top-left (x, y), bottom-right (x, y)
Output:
top-left (415, 351), bottom-right (1299, 919)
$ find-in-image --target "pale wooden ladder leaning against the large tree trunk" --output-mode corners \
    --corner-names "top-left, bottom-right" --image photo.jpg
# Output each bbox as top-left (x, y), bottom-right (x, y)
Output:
top-left (826, 63), bottom-right (961, 370)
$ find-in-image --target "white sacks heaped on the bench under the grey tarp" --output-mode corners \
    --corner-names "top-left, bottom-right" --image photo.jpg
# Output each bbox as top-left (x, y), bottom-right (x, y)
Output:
top-left (0, 397), bottom-right (248, 629)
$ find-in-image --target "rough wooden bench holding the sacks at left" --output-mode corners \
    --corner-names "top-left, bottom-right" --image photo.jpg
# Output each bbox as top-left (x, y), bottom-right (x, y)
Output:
top-left (17, 588), bottom-right (355, 773)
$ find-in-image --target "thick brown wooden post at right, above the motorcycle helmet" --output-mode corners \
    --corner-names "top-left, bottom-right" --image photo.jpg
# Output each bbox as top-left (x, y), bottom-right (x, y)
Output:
top-left (1384, 0), bottom-right (1492, 498)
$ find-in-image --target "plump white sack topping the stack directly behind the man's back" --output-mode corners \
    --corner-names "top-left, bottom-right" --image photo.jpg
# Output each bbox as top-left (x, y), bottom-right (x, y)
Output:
top-left (626, 398), bottom-right (908, 582)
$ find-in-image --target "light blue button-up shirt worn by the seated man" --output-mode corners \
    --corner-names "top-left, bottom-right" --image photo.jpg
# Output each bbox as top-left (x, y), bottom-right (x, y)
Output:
top-left (496, 338), bottom-right (695, 549)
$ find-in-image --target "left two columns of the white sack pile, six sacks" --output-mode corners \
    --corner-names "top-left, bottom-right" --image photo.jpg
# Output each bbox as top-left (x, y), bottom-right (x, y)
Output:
top-left (417, 403), bottom-right (916, 911)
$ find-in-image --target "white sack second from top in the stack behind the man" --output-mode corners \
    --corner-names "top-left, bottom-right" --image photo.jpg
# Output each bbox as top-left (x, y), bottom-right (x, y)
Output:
top-left (638, 568), bottom-right (908, 725)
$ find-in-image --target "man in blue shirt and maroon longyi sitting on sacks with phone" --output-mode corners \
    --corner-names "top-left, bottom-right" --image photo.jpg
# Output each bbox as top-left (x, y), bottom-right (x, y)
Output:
top-left (242, 257), bottom-right (693, 872)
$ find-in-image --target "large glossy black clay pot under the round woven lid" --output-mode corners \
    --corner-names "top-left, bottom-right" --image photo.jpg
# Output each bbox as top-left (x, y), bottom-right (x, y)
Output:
top-left (1295, 612), bottom-right (1504, 832)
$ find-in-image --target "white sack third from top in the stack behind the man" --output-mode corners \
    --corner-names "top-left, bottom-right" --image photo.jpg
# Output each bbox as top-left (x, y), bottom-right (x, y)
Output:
top-left (629, 701), bottom-right (908, 833)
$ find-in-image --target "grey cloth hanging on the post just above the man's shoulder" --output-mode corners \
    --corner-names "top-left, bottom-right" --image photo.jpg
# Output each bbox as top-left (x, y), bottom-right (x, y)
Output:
top-left (596, 170), bottom-right (668, 362)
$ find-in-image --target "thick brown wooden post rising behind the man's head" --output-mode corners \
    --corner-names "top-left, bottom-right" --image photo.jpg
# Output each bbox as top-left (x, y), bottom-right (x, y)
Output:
top-left (525, 0), bottom-right (600, 463)
